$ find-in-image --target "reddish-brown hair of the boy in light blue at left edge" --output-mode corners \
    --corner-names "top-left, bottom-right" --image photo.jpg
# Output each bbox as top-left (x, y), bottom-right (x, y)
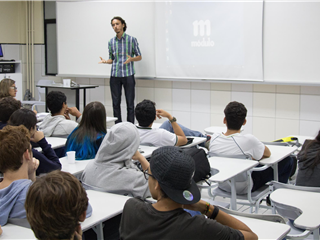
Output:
top-left (0, 126), bottom-right (31, 173)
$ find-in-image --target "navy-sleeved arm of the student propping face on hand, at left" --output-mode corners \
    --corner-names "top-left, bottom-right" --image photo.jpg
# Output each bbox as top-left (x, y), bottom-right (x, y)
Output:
top-left (31, 131), bottom-right (61, 175)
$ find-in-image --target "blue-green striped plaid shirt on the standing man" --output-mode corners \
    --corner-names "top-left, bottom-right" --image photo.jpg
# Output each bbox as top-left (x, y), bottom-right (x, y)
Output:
top-left (108, 33), bottom-right (141, 77)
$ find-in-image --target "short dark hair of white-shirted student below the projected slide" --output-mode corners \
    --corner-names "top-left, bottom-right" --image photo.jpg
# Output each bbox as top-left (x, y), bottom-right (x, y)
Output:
top-left (224, 101), bottom-right (247, 130)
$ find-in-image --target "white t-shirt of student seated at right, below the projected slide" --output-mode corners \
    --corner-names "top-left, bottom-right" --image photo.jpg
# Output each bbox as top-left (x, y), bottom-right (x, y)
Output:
top-left (209, 133), bottom-right (265, 194)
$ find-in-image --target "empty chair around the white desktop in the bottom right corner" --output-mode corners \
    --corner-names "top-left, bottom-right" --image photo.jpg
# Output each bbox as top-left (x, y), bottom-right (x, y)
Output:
top-left (267, 181), bottom-right (320, 239)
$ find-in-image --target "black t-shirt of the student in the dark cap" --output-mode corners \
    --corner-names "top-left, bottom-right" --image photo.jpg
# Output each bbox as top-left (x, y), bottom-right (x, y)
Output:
top-left (120, 198), bottom-right (244, 240)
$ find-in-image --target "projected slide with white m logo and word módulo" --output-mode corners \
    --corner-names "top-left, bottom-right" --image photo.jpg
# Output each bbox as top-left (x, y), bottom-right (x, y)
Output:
top-left (156, 1), bottom-right (263, 80)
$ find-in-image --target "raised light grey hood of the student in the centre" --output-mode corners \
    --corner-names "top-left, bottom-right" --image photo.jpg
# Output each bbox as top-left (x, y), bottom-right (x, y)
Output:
top-left (94, 122), bottom-right (140, 165)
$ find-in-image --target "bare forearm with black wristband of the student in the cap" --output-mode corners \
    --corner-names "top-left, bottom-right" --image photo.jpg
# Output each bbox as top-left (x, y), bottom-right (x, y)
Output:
top-left (183, 200), bottom-right (258, 240)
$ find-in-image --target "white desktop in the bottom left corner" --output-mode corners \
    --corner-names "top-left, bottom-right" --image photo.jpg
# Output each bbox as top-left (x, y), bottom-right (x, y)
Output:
top-left (0, 223), bottom-right (37, 240)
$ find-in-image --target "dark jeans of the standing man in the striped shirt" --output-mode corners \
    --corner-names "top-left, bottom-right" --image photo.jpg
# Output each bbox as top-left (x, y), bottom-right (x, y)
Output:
top-left (110, 75), bottom-right (136, 123)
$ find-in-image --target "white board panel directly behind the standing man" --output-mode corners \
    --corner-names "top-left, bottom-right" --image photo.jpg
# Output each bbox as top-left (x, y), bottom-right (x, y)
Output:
top-left (56, 1), bottom-right (155, 77)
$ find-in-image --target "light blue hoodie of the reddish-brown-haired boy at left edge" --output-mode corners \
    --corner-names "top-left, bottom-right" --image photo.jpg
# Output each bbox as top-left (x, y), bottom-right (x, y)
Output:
top-left (0, 179), bottom-right (32, 225)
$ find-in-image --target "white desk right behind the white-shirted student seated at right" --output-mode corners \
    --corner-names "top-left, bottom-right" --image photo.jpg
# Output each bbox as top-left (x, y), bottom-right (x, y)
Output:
top-left (208, 157), bottom-right (259, 210)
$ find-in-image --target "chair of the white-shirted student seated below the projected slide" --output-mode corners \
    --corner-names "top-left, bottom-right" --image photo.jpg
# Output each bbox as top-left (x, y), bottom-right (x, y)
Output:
top-left (208, 153), bottom-right (269, 214)
